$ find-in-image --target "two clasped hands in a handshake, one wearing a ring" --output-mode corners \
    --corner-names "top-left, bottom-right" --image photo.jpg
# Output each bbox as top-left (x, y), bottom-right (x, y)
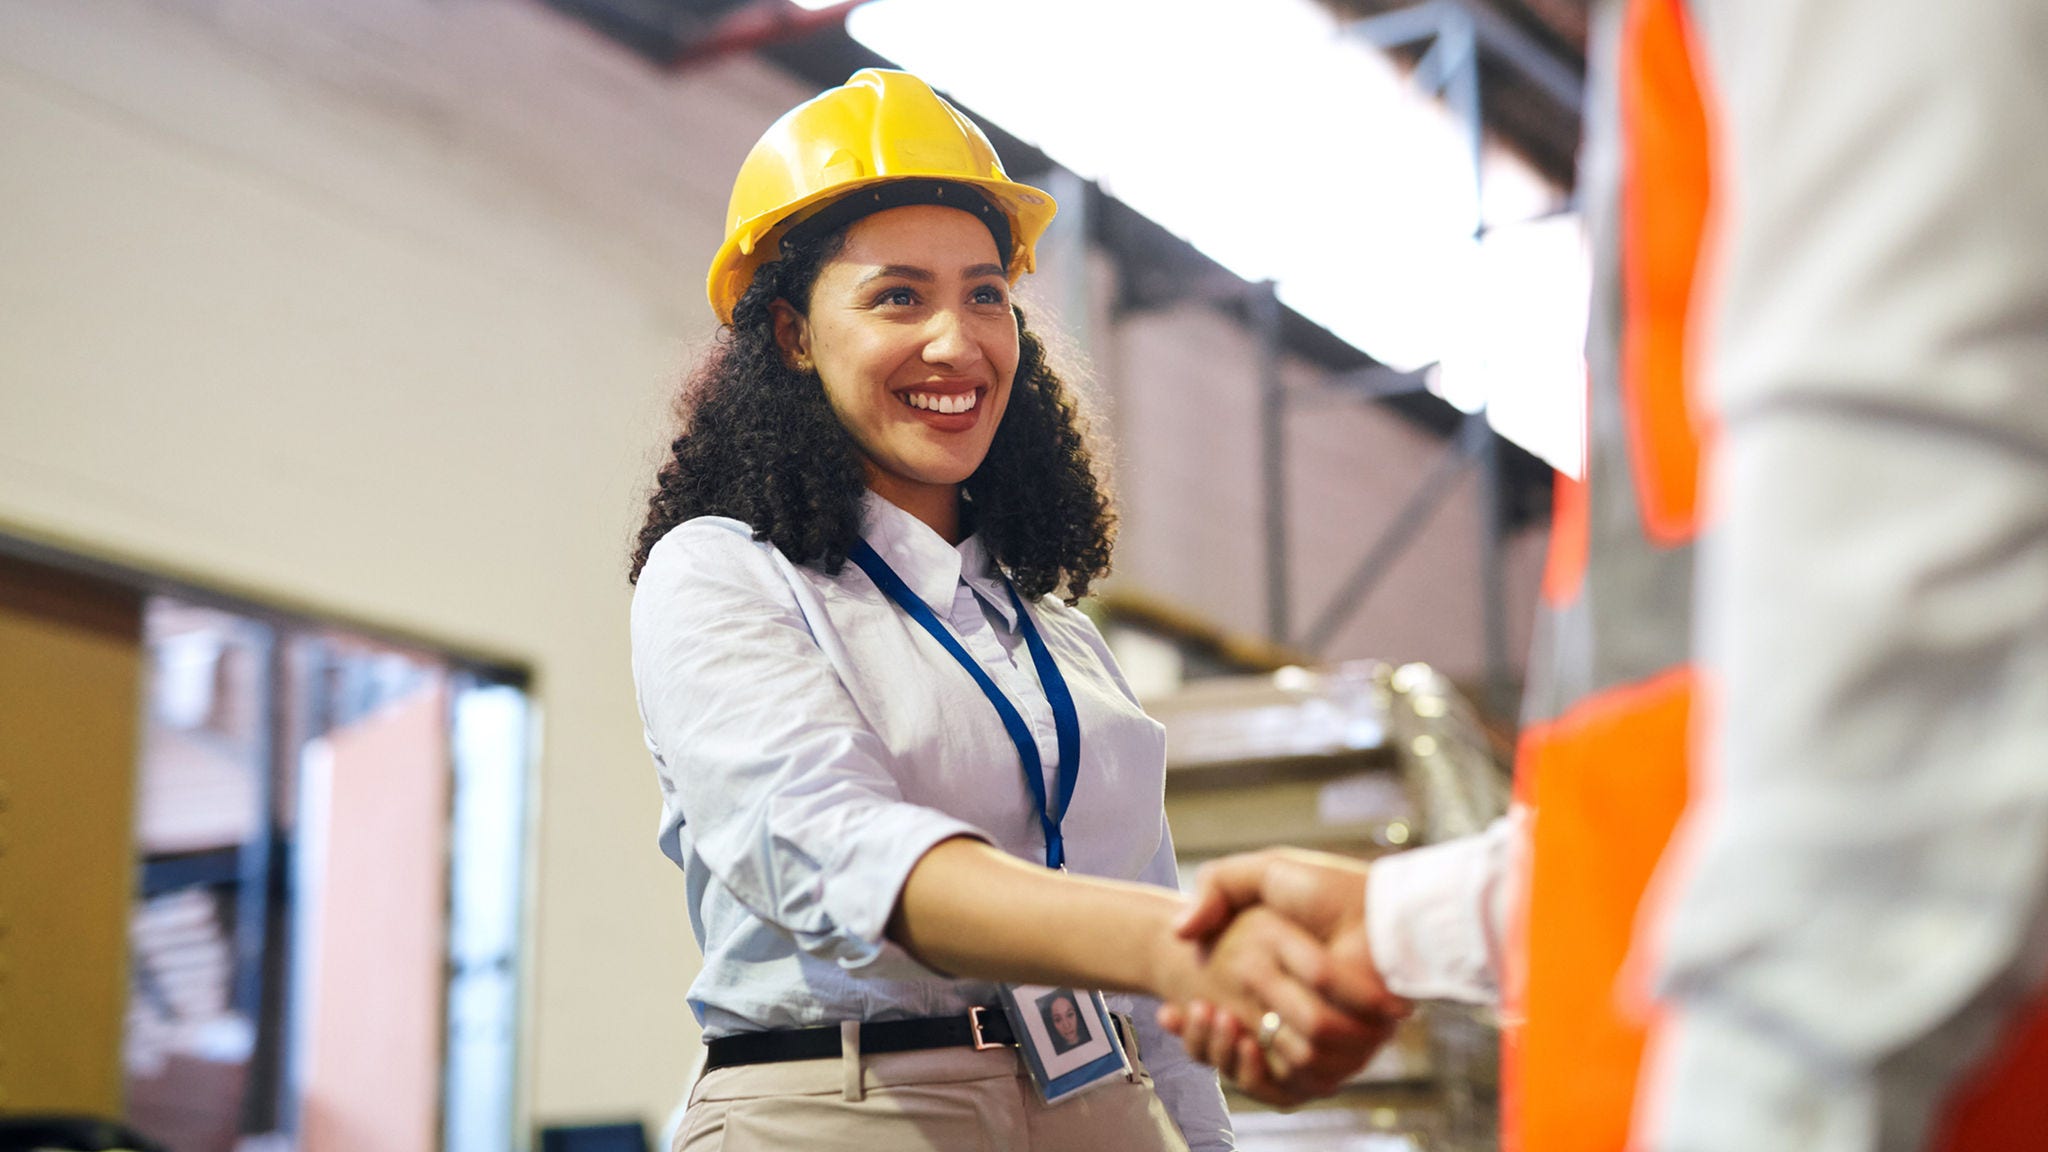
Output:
top-left (1157, 849), bottom-right (1411, 1107)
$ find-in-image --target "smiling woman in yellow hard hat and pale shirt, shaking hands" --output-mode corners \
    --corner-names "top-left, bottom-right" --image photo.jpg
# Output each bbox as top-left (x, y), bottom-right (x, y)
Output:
top-left (633, 70), bottom-right (1362, 1152)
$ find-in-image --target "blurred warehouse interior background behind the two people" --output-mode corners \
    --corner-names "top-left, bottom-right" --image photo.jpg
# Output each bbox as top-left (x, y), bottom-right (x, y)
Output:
top-left (0, 0), bottom-right (1589, 1152)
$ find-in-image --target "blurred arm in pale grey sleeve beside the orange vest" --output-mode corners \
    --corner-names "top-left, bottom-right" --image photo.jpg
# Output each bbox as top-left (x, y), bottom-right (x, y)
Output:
top-left (1638, 0), bottom-right (2048, 1152)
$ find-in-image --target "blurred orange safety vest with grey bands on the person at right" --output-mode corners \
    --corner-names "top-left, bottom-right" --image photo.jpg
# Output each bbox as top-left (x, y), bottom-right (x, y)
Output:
top-left (1501, 0), bottom-right (2048, 1152)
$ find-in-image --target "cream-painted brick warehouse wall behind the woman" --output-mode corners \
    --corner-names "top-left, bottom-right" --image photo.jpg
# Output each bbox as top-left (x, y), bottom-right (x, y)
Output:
top-left (0, 0), bottom-right (1534, 1121)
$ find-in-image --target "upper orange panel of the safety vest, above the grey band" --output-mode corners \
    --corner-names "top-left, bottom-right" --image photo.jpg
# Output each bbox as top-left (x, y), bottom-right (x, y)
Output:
top-left (1620, 0), bottom-right (1712, 545)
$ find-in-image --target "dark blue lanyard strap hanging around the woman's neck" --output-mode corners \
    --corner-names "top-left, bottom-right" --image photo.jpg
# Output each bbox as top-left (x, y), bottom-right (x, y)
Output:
top-left (848, 539), bottom-right (1081, 867)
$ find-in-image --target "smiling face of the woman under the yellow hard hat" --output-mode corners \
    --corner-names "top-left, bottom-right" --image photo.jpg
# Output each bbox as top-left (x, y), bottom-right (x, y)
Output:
top-left (774, 205), bottom-right (1018, 539)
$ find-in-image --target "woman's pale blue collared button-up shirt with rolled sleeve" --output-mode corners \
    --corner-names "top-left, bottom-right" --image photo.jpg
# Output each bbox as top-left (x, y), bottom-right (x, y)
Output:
top-left (633, 492), bottom-right (1233, 1150)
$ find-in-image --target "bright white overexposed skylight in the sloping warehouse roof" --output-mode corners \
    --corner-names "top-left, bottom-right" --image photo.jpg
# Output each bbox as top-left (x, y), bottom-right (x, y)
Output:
top-left (848, 0), bottom-right (1587, 471)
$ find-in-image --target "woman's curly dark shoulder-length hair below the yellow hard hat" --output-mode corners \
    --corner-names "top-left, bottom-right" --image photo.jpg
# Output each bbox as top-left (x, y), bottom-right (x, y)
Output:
top-left (629, 230), bottom-right (1116, 603)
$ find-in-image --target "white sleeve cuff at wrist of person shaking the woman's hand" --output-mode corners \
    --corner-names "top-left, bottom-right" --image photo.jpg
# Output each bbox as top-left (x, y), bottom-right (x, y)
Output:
top-left (1366, 808), bottom-right (1528, 1004)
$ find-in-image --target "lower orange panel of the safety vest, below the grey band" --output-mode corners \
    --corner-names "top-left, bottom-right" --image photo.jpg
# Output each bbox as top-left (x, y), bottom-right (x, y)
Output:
top-left (1501, 668), bottom-right (1696, 1152)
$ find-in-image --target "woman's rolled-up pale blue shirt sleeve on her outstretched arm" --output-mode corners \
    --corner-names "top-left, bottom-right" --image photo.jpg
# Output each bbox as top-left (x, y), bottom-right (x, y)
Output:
top-left (633, 521), bottom-right (989, 978)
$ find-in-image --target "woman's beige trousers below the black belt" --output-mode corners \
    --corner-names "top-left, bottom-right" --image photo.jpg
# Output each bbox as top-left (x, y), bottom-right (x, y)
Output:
top-left (672, 1033), bottom-right (1188, 1152)
